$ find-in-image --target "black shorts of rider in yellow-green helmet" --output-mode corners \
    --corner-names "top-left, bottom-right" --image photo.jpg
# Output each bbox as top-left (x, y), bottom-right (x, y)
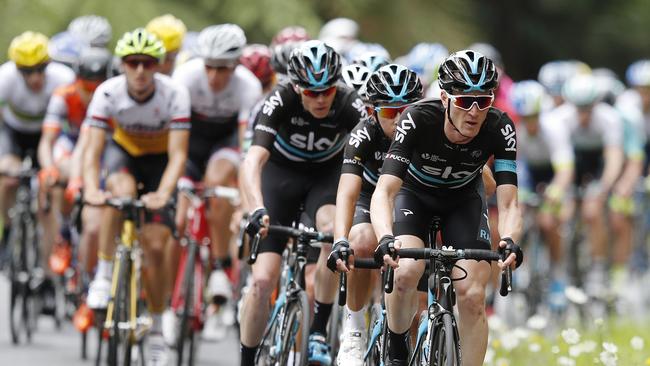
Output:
top-left (103, 140), bottom-right (176, 232)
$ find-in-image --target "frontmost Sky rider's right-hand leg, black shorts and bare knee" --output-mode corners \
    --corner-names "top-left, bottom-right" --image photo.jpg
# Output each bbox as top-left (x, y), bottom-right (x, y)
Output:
top-left (442, 185), bottom-right (492, 366)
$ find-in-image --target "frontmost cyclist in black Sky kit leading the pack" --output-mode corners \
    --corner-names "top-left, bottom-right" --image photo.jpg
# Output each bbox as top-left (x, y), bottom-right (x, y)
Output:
top-left (370, 50), bottom-right (523, 366)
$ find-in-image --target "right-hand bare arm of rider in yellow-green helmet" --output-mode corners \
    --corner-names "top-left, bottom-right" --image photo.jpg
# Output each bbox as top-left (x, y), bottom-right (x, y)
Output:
top-left (157, 129), bottom-right (190, 201)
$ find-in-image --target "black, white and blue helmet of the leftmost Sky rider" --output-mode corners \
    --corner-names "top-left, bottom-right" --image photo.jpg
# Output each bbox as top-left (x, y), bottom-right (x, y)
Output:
top-left (287, 41), bottom-right (341, 89)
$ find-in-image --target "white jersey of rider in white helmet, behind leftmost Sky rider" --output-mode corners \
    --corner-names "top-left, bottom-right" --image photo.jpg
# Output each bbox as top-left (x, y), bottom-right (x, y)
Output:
top-left (173, 58), bottom-right (262, 125)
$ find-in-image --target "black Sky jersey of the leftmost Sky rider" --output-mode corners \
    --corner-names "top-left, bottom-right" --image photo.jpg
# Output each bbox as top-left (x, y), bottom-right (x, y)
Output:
top-left (253, 84), bottom-right (368, 169)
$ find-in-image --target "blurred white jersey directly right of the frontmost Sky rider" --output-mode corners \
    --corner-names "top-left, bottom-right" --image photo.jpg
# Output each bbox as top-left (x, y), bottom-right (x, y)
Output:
top-left (517, 113), bottom-right (574, 169)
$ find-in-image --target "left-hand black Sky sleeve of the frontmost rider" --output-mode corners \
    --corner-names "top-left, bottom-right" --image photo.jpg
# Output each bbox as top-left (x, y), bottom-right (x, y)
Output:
top-left (381, 107), bottom-right (421, 179)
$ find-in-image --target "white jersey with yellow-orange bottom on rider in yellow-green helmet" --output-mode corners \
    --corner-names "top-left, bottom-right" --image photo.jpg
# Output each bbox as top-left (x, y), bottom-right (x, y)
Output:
top-left (84, 73), bottom-right (190, 156)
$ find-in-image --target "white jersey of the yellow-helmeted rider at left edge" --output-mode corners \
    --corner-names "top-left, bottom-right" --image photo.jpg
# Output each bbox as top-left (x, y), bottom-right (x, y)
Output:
top-left (0, 61), bottom-right (75, 133)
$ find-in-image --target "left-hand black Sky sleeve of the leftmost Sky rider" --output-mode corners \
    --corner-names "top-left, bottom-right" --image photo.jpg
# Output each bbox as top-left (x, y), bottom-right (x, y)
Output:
top-left (253, 86), bottom-right (293, 151)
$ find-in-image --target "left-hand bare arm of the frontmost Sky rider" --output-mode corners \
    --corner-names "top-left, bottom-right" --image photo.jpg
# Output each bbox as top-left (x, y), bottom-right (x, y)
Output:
top-left (370, 174), bottom-right (402, 241)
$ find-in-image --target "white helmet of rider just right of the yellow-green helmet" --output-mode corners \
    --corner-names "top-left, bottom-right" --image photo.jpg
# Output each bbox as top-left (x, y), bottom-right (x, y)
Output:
top-left (197, 24), bottom-right (246, 60)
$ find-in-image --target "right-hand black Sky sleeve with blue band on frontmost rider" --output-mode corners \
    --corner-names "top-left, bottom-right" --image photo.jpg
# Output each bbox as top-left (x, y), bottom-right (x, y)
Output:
top-left (494, 113), bottom-right (517, 185)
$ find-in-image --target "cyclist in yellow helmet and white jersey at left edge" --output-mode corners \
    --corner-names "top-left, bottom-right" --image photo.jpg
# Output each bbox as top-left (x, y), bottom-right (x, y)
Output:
top-left (0, 31), bottom-right (75, 270)
